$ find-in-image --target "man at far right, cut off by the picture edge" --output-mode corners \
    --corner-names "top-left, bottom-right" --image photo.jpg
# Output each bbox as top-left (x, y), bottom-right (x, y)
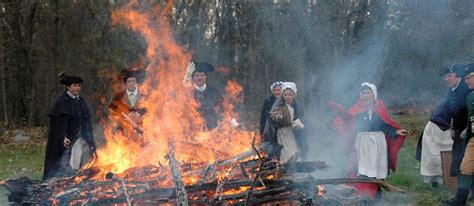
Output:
top-left (444, 64), bottom-right (474, 206)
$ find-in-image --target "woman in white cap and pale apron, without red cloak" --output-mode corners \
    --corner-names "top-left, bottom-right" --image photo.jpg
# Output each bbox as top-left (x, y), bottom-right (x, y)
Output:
top-left (263, 82), bottom-right (304, 163)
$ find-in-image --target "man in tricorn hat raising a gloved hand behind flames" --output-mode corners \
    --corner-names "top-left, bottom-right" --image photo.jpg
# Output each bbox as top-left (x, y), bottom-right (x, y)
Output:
top-left (184, 62), bottom-right (223, 129)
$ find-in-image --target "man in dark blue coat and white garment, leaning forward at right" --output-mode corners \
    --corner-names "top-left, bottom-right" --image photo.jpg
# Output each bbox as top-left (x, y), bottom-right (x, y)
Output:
top-left (420, 65), bottom-right (469, 187)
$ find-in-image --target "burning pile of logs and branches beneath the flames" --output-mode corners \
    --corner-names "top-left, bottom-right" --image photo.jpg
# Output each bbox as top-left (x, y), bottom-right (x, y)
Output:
top-left (3, 142), bottom-right (401, 205)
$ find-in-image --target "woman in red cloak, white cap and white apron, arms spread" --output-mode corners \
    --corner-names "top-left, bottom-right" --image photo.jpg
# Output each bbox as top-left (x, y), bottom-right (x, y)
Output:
top-left (328, 82), bottom-right (407, 197)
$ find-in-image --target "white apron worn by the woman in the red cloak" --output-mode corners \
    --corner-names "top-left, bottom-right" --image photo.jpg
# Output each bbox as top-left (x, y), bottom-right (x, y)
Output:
top-left (355, 131), bottom-right (388, 179)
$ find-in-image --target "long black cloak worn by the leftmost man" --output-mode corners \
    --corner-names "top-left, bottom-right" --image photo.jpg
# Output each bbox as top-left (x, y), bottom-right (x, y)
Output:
top-left (43, 92), bottom-right (95, 180)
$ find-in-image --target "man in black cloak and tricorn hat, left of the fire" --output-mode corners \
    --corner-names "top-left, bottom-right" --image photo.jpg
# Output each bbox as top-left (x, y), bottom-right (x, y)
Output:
top-left (43, 73), bottom-right (95, 180)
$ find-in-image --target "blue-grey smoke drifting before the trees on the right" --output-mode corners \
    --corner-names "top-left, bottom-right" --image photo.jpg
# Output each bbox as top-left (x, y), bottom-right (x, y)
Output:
top-left (297, 0), bottom-right (472, 172)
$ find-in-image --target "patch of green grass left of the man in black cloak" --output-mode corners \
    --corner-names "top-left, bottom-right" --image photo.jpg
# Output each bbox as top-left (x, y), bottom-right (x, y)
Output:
top-left (0, 144), bottom-right (46, 179)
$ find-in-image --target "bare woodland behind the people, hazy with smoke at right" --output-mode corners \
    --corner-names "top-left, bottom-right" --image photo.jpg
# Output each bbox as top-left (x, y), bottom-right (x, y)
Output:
top-left (0, 0), bottom-right (474, 127)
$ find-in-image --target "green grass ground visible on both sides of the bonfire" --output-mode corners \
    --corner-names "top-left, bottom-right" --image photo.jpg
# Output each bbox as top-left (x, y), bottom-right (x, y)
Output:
top-left (0, 114), bottom-right (474, 205)
